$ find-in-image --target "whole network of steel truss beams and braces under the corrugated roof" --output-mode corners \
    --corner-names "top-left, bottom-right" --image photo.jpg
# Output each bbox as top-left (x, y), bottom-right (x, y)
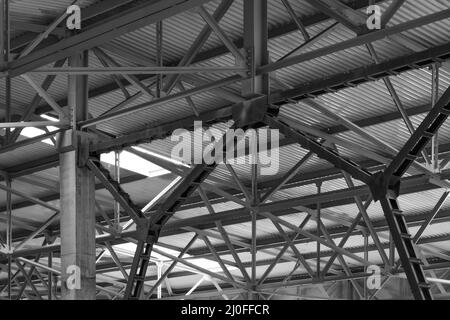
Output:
top-left (0, 0), bottom-right (450, 299)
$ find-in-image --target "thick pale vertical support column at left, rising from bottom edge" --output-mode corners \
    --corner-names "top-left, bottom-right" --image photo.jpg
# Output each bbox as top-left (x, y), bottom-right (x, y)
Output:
top-left (59, 52), bottom-right (96, 300)
